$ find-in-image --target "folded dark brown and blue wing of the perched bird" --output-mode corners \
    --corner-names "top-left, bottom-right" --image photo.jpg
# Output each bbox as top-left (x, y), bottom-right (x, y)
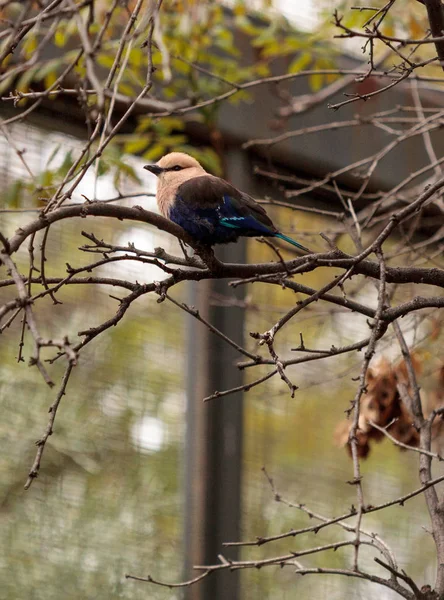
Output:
top-left (177, 175), bottom-right (276, 233)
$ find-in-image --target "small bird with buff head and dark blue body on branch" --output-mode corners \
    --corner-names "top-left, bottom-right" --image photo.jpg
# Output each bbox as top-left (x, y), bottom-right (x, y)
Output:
top-left (143, 152), bottom-right (311, 253)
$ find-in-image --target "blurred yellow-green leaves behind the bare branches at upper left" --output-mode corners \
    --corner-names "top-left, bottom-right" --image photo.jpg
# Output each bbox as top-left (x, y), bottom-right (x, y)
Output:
top-left (0, 0), bottom-right (350, 208)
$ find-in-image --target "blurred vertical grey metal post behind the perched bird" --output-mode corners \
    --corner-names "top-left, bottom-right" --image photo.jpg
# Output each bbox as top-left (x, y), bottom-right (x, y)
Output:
top-left (185, 151), bottom-right (251, 600)
